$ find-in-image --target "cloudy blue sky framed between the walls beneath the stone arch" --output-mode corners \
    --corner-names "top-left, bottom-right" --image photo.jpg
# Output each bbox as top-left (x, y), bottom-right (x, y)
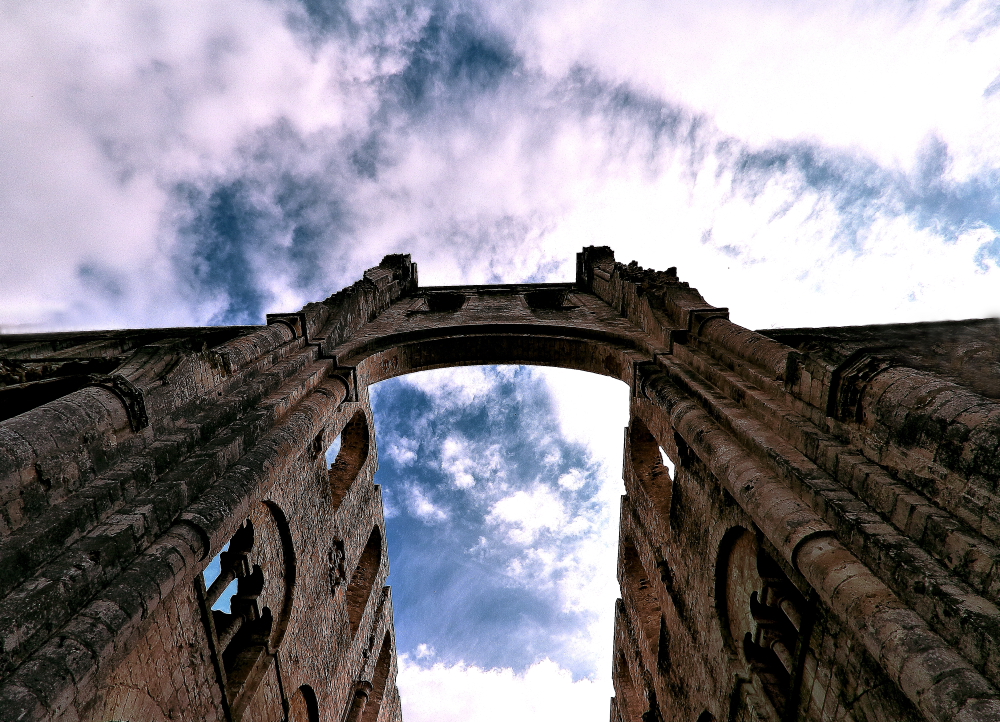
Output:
top-left (372, 366), bottom-right (628, 720)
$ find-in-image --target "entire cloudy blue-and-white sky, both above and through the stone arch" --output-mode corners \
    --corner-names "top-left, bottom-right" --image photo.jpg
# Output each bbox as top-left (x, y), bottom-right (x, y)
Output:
top-left (0, 0), bottom-right (1000, 722)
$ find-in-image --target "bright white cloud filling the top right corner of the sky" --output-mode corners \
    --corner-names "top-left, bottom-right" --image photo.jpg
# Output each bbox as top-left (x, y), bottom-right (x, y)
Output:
top-left (493, 0), bottom-right (1000, 172)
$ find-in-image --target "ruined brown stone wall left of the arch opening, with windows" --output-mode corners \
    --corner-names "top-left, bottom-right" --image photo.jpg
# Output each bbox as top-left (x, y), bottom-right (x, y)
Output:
top-left (0, 257), bottom-right (415, 722)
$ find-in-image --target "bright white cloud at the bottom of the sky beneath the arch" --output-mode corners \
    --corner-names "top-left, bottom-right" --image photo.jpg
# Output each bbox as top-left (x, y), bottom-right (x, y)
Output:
top-left (397, 655), bottom-right (614, 722)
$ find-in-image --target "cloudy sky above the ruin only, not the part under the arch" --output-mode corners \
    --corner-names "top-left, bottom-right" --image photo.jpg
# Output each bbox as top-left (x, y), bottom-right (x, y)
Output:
top-left (7, 0), bottom-right (1000, 328)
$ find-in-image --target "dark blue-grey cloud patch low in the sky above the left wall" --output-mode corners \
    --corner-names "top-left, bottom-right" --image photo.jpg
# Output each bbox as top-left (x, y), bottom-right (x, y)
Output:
top-left (173, 123), bottom-right (351, 324)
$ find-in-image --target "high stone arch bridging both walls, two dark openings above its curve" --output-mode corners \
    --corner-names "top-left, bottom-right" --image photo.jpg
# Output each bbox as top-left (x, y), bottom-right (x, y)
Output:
top-left (332, 283), bottom-right (652, 388)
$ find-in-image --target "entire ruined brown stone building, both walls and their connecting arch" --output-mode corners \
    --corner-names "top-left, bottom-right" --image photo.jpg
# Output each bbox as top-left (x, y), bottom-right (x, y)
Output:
top-left (0, 248), bottom-right (1000, 722)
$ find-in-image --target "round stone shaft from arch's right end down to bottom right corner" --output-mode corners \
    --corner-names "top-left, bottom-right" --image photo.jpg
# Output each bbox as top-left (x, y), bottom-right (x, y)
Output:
top-left (642, 372), bottom-right (1000, 722)
